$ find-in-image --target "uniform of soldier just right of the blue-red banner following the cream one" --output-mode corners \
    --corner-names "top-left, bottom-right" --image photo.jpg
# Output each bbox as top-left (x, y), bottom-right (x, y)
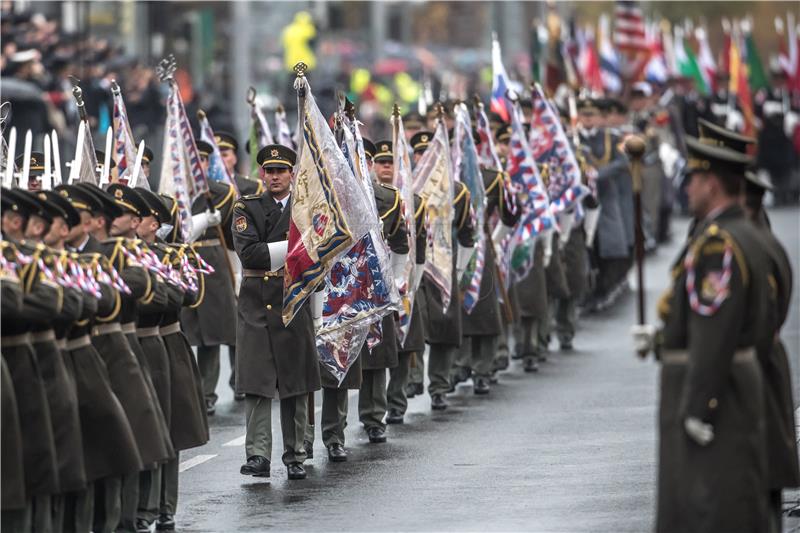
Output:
top-left (461, 169), bottom-right (519, 394)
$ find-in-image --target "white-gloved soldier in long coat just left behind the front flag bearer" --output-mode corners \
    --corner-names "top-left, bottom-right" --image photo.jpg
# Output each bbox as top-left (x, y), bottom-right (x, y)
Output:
top-left (181, 140), bottom-right (236, 415)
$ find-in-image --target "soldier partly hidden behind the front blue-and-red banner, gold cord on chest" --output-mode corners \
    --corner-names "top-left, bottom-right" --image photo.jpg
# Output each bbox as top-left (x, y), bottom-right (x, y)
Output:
top-left (358, 140), bottom-right (409, 443)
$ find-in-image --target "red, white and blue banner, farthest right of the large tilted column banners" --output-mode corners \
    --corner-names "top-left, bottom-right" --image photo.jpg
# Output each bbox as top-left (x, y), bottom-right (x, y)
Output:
top-left (530, 86), bottom-right (589, 216)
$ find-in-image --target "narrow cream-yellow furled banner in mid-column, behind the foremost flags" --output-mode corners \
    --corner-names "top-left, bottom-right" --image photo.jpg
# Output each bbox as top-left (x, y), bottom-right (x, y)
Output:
top-left (414, 121), bottom-right (454, 310)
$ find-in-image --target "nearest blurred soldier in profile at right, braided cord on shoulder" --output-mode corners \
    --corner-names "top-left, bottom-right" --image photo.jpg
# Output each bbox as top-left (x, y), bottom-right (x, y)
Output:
top-left (632, 137), bottom-right (774, 531)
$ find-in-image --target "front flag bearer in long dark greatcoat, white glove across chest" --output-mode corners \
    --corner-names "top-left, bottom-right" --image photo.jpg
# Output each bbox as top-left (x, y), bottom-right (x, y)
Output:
top-left (232, 145), bottom-right (322, 479)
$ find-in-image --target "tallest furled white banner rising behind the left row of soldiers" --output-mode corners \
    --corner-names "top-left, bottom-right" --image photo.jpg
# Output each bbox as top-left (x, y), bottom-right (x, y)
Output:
top-left (158, 81), bottom-right (208, 241)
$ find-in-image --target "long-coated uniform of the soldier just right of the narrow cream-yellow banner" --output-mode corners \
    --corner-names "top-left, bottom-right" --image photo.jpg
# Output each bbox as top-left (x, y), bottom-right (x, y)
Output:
top-left (417, 181), bottom-right (475, 410)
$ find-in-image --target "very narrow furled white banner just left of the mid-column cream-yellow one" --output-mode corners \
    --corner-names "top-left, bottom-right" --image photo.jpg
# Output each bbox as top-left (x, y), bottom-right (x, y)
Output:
top-left (392, 113), bottom-right (417, 346)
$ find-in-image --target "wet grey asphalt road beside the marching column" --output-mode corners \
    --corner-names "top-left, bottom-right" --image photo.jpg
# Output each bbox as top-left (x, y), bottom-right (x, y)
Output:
top-left (176, 209), bottom-right (800, 532)
